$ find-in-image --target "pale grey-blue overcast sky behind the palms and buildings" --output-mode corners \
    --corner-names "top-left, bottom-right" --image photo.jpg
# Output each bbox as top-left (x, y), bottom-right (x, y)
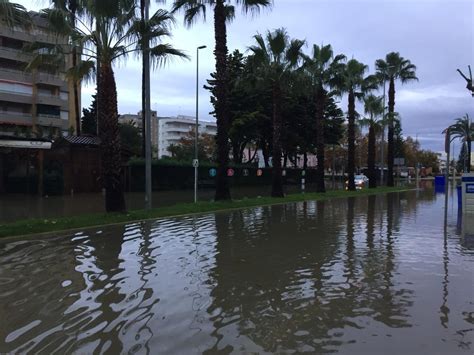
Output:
top-left (16, 0), bottom-right (474, 151)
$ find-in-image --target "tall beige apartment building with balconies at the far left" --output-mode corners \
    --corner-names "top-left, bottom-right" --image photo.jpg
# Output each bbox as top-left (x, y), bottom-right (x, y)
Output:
top-left (0, 12), bottom-right (80, 137)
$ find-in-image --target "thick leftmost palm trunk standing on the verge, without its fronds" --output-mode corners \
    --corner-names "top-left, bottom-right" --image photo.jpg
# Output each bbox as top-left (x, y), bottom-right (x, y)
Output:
top-left (97, 62), bottom-right (126, 212)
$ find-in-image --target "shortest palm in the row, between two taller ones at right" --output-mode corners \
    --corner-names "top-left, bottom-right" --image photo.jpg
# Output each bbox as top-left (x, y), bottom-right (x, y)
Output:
top-left (360, 95), bottom-right (383, 188)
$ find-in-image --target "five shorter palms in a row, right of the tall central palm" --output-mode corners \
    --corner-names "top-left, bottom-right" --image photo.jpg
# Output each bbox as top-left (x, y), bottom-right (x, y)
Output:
top-left (249, 29), bottom-right (418, 197)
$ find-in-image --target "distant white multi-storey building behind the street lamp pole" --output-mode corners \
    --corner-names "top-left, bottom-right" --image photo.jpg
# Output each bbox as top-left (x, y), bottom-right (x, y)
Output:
top-left (158, 115), bottom-right (217, 158)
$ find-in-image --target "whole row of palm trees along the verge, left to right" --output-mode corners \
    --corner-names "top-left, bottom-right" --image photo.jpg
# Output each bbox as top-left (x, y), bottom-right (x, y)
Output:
top-left (0, 0), bottom-right (417, 211)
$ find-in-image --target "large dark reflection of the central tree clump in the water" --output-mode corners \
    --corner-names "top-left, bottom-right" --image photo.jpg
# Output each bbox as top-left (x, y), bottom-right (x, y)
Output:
top-left (207, 203), bottom-right (344, 353)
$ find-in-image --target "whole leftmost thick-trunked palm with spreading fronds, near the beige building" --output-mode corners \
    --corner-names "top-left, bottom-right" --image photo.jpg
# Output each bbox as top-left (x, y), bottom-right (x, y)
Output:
top-left (39, 0), bottom-right (184, 212)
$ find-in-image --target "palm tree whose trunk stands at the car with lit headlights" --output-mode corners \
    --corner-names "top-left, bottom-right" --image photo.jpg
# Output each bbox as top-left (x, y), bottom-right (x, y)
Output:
top-left (338, 59), bottom-right (377, 191)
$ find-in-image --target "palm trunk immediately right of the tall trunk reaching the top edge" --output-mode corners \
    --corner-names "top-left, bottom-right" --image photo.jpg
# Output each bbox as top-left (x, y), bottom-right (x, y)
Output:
top-left (272, 82), bottom-right (284, 197)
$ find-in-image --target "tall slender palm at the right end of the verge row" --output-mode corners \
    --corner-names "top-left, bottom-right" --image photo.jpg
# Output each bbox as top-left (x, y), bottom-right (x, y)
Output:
top-left (375, 52), bottom-right (418, 186)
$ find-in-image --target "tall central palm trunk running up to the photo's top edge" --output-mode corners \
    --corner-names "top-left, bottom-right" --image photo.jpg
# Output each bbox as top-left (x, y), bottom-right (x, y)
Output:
top-left (214, 0), bottom-right (231, 201)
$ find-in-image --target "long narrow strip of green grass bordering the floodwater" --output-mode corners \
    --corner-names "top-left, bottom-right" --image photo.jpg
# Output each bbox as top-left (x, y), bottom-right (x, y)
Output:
top-left (0, 187), bottom-right (410, 237)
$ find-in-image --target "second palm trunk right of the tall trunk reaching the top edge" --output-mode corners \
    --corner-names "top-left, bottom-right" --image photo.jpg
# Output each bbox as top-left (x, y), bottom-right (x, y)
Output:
top-left (315, 88), bottom-right (326, 192)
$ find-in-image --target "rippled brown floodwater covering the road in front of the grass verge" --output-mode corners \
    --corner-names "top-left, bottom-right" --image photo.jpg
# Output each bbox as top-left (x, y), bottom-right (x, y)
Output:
top-left (0, 189), bottom-right (474, 355)
